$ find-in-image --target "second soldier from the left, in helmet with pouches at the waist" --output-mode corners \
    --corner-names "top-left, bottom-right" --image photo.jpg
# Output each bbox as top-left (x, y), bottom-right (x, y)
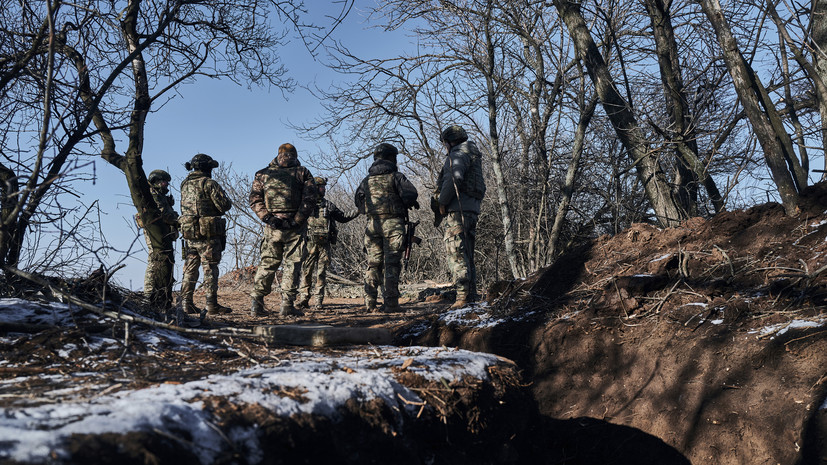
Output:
top-left (179, 153), bottom-right (233, 315)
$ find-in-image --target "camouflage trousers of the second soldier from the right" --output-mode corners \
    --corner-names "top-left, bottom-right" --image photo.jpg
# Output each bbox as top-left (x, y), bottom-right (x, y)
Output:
top-left (365, 217), bottom-right (405, 305)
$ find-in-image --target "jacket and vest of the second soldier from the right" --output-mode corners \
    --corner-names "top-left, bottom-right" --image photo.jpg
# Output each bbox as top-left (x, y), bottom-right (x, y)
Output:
top-left (353, 160), bottom-right (419, 217)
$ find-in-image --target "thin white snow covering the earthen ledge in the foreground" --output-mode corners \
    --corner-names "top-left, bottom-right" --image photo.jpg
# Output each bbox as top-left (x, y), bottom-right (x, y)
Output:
top-left (0, 346), bottom-right (500, 464)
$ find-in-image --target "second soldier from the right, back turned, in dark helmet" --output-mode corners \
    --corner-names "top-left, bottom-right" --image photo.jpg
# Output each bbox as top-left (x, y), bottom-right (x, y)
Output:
top-left (354, 143), bottom-right (419, 312)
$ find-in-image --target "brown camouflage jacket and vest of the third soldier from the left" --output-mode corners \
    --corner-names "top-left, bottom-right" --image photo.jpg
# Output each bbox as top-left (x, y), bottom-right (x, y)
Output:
top-left (250, 159), bottom-right (318, 223)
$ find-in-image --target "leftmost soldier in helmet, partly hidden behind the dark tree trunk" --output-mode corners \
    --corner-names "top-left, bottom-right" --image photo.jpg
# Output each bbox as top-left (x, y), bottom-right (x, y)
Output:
top-left (142, 170), bottom-right (178, 311)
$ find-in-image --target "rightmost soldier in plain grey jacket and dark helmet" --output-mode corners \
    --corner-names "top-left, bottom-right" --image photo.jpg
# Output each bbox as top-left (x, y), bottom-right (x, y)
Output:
top-left (432, 125), bottom-right (485, 309)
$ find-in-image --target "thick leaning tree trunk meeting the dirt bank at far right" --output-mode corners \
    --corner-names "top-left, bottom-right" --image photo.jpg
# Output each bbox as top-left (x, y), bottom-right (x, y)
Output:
top-left (701, 0), bottom-right (799, 215)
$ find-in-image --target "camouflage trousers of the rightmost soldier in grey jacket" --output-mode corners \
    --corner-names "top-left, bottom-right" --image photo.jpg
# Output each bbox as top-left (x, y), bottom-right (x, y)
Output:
top-left (442, 212), bottom-right (479, 300)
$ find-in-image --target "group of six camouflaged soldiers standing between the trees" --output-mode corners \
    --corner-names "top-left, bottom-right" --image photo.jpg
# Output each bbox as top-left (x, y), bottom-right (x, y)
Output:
top-left (137, 125), bottom-right (485, 324)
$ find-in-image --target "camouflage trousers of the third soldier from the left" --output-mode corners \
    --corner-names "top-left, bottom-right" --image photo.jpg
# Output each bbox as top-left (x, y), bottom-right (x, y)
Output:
top-left (252, 226), bottom-right (306, 302)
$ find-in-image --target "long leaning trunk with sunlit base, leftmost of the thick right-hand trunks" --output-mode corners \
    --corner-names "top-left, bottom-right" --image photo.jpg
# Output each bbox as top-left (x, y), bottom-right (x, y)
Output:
top-left (554, 0), bottom-right (687, 227)
